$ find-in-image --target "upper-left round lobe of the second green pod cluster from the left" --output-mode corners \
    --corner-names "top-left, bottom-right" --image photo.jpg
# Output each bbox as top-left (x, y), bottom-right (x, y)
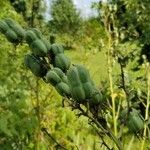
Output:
top-left (25, 30), bottom-right (38, 45)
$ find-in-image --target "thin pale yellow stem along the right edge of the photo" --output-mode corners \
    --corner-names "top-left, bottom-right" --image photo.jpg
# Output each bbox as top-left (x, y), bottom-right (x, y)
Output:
top-left (141, 67), bottom-right (150, 150)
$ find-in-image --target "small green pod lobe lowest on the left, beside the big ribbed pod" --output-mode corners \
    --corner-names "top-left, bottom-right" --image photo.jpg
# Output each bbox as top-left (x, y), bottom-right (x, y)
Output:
top-left (55, 82), bottom-right (70, 96)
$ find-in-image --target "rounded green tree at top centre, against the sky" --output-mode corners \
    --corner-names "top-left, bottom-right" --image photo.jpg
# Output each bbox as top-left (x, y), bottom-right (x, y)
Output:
top-left (50, 0), bottom-right (82, 34)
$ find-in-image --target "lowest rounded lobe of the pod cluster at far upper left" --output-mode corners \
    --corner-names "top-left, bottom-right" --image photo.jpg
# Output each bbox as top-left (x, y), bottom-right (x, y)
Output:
top-left (5, 29), bottom-right (18, 43)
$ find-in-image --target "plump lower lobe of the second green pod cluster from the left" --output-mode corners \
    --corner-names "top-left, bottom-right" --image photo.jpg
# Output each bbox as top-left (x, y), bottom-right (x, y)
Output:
top-left (30, 39), bottom-right (47, 57)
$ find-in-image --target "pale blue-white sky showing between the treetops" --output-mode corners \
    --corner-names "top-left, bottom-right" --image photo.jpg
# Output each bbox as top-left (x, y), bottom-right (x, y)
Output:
top-left (45, 0), bottom-right (99, 18)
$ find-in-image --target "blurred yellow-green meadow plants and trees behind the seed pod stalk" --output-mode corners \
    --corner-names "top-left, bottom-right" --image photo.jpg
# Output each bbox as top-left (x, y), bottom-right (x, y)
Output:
top-left (0, 0), bottom-right (150, 150)
